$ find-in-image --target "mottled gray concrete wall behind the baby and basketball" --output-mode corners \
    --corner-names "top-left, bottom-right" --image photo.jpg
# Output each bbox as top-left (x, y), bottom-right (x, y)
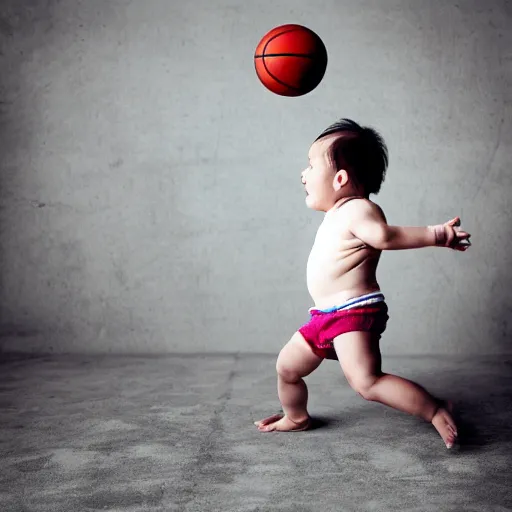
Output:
top-left (0, 0), bottom-right (512, 354)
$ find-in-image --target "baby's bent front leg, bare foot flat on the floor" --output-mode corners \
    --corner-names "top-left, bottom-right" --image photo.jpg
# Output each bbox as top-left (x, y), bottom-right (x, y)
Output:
top-left (254, 332), bottom-right (323, 432)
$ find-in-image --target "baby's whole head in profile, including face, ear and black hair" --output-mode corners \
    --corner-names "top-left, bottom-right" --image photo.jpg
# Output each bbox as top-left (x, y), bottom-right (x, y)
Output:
top-left (301, 119), bottom-right (388, 211)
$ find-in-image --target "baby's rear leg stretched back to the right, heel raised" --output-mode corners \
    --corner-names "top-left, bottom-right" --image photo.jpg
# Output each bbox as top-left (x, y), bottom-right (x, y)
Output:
top-left (334, 332), bottom-right (457, 448)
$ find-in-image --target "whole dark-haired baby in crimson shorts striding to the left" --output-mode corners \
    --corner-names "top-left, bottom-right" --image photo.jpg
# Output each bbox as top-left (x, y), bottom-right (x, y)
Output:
top-left (255, 119), bottom-right (471, 448)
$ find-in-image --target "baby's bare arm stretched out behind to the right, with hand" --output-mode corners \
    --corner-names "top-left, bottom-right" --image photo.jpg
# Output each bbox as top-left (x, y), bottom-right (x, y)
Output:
top-left (350, 206), bottom-right (471, 251)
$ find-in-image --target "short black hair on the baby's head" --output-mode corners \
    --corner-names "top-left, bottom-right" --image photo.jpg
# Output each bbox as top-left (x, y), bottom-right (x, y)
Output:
top-left (315, 118), bottom-right (389, 197)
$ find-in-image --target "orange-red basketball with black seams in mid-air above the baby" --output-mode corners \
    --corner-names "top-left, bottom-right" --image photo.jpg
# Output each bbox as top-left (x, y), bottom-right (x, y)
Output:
top-left (254, 25), bottom-right (327, 96)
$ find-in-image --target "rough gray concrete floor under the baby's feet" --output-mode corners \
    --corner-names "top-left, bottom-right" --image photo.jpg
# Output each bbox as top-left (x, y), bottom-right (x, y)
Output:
top-left (0, 355), bottom-right (512, 512)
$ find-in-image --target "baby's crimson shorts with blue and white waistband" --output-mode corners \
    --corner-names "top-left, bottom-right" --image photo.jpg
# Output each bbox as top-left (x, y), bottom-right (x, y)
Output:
top-left (299, 302), bottom-right (389, 360)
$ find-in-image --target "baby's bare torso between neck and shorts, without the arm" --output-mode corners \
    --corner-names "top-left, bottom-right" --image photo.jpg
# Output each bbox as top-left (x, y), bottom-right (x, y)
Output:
top-left (307, 199), bottom-right (384, 309)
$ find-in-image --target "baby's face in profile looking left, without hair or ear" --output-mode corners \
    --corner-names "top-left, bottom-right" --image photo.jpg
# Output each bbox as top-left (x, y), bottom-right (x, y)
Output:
top-left (301, 137), bottom-right (338, 211)
